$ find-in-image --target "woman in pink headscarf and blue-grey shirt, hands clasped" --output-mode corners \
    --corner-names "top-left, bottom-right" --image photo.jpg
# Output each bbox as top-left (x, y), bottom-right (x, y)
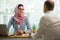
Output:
top-left (8, 4), bottom-right (31, 34)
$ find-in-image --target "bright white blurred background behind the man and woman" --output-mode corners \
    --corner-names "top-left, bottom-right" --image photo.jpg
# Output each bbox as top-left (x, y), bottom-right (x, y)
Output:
top-left (0, 0), bottom-right (60, 34)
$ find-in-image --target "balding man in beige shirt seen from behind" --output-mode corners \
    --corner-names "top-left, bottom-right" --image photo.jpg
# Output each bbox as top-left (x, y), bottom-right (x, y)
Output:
top-left (33, 1), bottom-right (60, 40)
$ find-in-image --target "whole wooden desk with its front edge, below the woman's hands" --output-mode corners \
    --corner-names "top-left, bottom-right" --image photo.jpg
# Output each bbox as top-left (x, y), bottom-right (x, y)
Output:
top-left (0, 34), bottom-right (32, 40)
